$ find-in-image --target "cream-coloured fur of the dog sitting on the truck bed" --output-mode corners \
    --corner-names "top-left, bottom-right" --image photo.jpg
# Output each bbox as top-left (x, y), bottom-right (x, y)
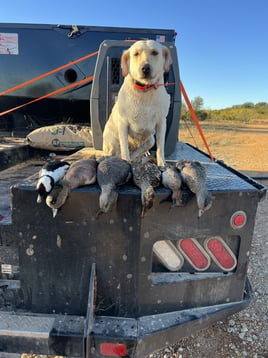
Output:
top-left (103, 40), bottom-right (172, 166)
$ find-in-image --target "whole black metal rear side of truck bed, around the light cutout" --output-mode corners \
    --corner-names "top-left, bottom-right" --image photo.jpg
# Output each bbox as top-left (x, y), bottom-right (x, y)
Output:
top-left (3, 182), bottom-right (258, 317)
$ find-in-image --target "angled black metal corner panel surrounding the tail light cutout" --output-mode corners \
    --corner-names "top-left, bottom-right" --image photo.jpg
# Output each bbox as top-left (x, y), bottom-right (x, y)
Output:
top-left (137, 189), bottom-right (258, 315)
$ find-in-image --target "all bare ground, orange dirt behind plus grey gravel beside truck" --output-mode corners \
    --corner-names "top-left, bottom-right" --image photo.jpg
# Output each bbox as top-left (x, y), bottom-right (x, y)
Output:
top-left (0, 122), bottom-right (268, 358)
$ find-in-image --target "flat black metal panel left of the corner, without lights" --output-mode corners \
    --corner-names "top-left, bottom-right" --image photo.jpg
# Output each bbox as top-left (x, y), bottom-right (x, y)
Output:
top-left (7, 187), bottom-right (139, 315)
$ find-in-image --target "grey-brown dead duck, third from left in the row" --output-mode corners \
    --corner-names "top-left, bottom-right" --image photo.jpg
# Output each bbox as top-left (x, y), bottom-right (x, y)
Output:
top-left (96, 156), bottom-right (131, 217)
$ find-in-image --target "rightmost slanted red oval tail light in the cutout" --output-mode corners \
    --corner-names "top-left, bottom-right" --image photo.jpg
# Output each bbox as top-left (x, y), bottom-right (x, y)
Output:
top-left (204, 237), bottom-right (237, 271)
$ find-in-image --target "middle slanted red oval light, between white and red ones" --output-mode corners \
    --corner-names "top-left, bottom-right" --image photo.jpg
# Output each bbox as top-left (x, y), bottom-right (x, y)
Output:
top-left (178, 239), bottom-right (210, 271)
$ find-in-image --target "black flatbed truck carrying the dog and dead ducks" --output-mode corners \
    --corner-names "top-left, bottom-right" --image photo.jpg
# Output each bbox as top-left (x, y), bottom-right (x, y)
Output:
top-left (0, 24), bottom-right (266, 358)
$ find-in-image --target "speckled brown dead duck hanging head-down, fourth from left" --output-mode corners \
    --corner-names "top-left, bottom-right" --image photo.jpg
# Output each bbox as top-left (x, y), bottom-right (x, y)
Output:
top-left (132, 157), bottom-right (161, 218)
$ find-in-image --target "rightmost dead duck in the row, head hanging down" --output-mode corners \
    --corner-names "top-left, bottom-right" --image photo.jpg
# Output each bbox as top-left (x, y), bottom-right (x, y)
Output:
top-left (176, 159), bottom-right (212, 218)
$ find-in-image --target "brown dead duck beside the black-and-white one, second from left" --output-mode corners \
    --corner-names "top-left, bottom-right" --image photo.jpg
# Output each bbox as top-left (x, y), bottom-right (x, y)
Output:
top-left (46, 159), bottom-right (97, 217)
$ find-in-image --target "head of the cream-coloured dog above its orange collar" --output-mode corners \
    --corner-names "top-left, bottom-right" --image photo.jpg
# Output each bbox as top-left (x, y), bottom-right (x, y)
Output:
top-left (121, 40), bottom-right (172, 85)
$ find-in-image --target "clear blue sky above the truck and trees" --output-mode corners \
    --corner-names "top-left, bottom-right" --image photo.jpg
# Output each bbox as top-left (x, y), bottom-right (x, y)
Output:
top-left (0, 0), bottom-right (268, 109)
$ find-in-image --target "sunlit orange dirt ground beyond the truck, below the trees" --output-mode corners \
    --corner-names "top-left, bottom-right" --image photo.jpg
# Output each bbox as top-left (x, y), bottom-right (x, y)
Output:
top-left (179, 120), bottom-right (268, 172)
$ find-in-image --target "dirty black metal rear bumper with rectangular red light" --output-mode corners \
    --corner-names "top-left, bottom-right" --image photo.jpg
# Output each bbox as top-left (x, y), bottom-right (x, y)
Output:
top-left (0, 275), bottom-right (253, 358)
